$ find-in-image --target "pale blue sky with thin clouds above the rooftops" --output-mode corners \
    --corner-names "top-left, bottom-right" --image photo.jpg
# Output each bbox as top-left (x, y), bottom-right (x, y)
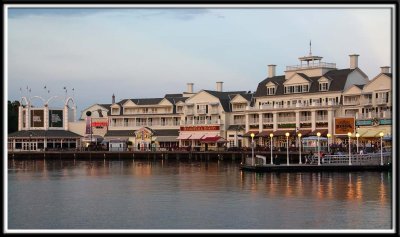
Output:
top-left (7, 5), bottom-right (392, 113)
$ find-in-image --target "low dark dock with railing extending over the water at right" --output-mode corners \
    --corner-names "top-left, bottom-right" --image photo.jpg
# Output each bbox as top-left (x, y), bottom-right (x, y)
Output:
top-left (240, 152), bottom-right (392, 172)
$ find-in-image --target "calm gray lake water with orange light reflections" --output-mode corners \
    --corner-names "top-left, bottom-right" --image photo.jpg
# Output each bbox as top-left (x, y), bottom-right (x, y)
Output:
top-left (7, 159), bottom-right (392, 230)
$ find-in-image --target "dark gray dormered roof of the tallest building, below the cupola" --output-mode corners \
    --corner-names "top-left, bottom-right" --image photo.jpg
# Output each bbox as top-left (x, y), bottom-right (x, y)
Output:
top-left (254, 69), bottom-right (355, 97)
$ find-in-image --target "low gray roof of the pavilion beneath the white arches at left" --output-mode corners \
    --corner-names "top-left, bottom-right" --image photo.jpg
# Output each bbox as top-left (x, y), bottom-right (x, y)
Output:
top-left (8, 130), bottom-right (82, 138)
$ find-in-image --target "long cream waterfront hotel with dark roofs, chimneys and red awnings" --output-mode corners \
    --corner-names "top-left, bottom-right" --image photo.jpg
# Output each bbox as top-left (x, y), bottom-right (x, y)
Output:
top-left (7, 50), bottom-right (392, 153)
